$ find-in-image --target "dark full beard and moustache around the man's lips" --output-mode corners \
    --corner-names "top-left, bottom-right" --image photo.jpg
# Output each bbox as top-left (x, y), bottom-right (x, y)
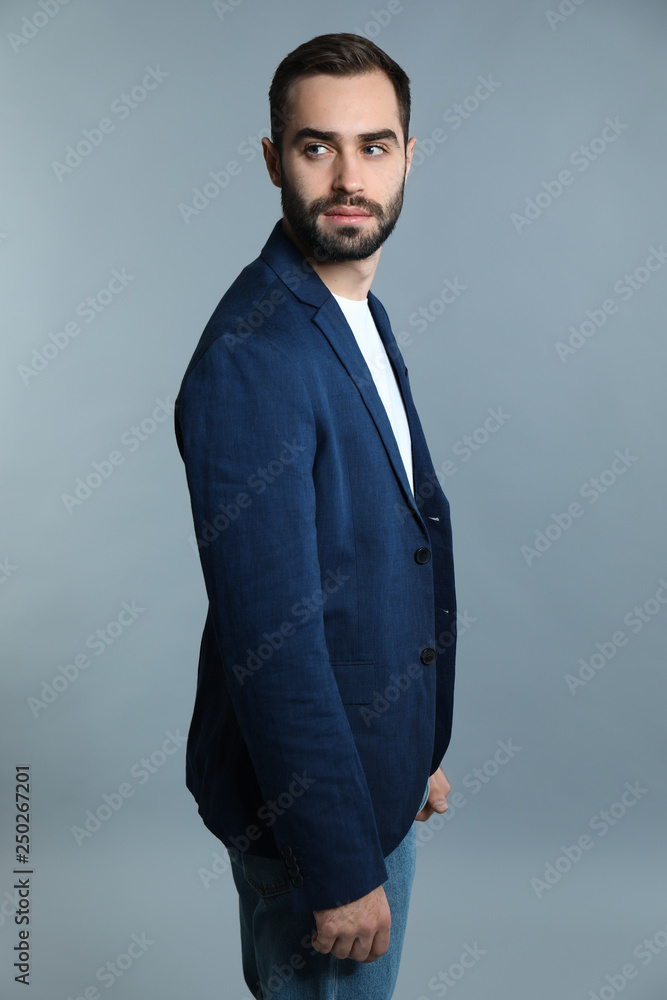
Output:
top-left (280, 163), bottom-right (405, 263)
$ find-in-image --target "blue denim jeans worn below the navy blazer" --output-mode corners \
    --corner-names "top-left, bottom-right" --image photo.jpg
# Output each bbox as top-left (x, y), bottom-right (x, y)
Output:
top-left (230, 784), bottom-right (428, 1000)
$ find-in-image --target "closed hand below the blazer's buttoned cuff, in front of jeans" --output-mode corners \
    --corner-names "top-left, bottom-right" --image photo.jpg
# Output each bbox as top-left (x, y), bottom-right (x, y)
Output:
top-left (311, 885), bottom-right (391, 962)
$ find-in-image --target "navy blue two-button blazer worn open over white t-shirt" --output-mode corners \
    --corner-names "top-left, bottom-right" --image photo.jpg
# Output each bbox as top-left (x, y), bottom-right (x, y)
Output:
top-left (175, 221), bottom-right (456, 912)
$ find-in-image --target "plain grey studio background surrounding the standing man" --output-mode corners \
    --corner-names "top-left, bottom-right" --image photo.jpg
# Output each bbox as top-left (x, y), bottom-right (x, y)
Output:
top-left (0, 0), bottom-right (667, 1000)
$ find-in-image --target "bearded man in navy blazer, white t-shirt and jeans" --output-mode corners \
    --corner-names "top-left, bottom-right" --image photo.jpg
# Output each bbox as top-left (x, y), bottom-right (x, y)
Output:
top-left (176, 34), bottom-right (456, 1000)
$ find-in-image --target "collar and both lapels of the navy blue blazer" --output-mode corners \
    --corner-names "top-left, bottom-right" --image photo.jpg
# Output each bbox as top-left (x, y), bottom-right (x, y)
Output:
top-left (260, 220), bottom-right (425, 522)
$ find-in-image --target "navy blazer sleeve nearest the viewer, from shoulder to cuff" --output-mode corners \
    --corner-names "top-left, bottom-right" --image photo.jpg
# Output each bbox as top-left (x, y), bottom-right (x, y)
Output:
top-left (176, 335), bottom-right (388, 912)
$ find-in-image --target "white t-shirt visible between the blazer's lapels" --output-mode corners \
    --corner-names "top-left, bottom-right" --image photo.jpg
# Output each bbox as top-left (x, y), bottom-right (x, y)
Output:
top-left (332, 293), bottom-right (415, 495)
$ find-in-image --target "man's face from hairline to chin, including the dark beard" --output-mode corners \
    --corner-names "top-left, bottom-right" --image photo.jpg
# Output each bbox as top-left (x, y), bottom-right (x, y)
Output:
top-left (274, 71), bottom-right (415, 262)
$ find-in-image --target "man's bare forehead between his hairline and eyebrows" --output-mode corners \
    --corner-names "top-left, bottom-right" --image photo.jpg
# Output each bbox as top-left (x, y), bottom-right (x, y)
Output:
top-left (287, 70), bottom-right (400, 135)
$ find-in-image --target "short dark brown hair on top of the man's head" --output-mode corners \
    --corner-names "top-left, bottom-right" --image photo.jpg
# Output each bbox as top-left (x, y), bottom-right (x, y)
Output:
top-left (269, 32), bottom-right (410, 154)
